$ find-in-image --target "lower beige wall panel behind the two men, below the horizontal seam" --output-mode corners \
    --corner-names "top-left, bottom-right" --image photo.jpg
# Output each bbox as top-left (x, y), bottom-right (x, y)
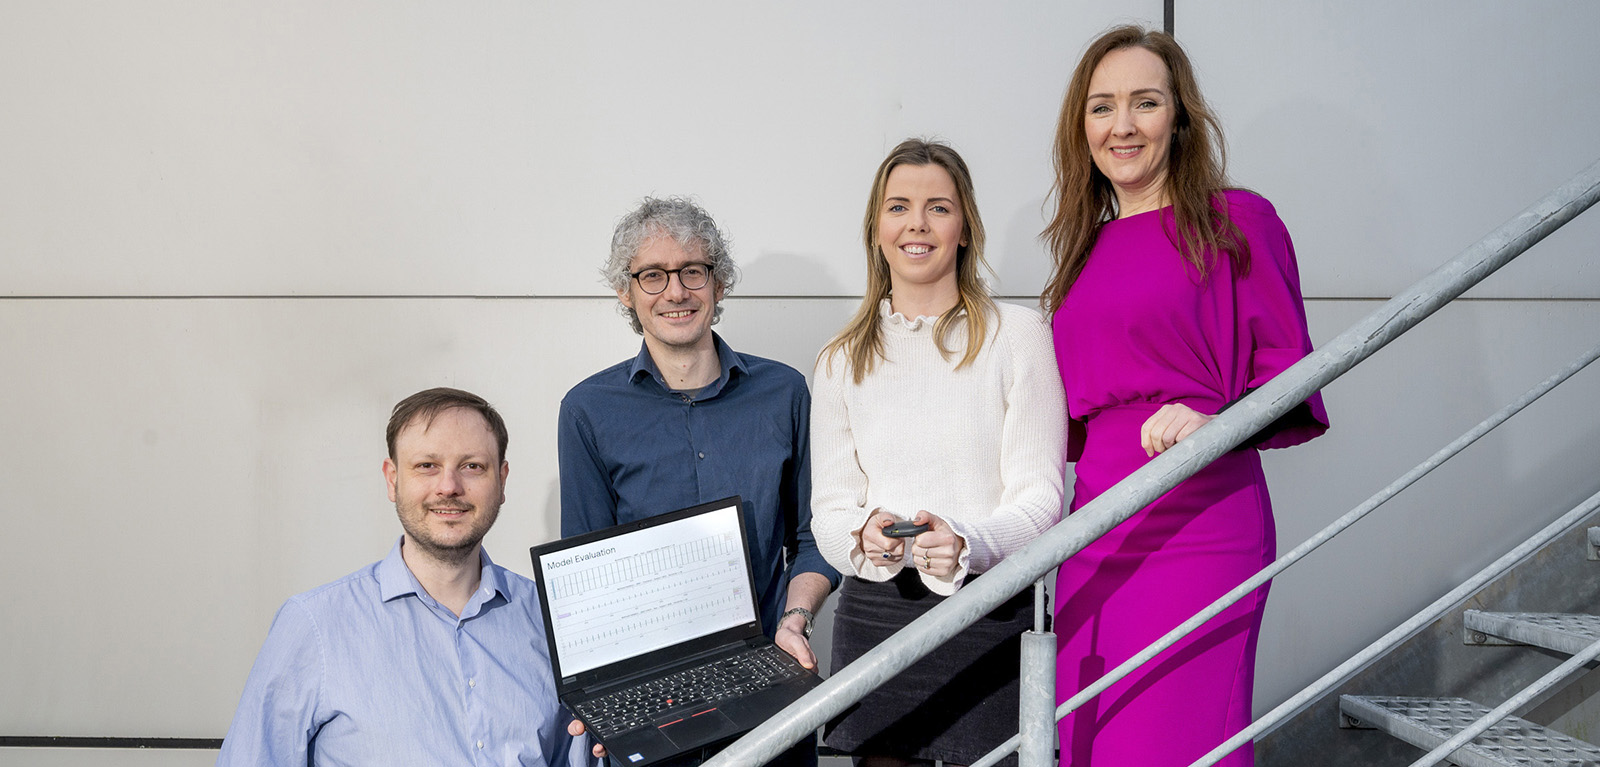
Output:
top-left (0, 299), bottom-right (850, 737)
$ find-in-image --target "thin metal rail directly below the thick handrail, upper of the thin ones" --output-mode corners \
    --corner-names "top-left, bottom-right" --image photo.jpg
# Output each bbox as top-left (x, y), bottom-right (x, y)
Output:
top-left (971, 344), bottom-right (1600, 767)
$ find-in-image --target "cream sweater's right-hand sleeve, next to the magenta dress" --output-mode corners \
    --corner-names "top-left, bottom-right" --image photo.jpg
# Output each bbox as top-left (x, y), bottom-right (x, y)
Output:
top-left (923, 311), bottom-right (1067, 582)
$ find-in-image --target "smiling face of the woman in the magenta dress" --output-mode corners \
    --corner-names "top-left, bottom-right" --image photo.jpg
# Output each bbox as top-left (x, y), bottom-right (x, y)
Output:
top-left (1083, 46), bottom-right (1178, 216)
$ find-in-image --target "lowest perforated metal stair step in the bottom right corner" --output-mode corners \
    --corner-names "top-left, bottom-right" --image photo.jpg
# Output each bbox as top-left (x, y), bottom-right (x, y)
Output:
top-left (1339, 695), bottom-right (1600, 767)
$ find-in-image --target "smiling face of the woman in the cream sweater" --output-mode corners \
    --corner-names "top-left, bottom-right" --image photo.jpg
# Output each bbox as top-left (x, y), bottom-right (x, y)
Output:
top-left (877, 165), bottom-right (966, 315)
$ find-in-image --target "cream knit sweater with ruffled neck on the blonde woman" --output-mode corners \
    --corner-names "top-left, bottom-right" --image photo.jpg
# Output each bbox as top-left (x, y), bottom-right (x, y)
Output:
top-left (811, 299), bottom-right (1066, 596)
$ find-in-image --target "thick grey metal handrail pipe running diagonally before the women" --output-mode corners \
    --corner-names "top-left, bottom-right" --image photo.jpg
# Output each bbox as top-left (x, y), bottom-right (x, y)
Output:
top-left (706, 162), bottom-right (1600, 767)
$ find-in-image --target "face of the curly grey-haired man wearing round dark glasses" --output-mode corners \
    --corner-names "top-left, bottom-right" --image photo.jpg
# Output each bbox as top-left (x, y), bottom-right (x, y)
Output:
top-left (616, 235), bottom-right (722, 359)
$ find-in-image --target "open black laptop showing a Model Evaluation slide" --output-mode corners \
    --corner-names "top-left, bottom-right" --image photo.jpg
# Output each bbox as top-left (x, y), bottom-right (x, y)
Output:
top-left (531, 496), bottom-right (822, 767)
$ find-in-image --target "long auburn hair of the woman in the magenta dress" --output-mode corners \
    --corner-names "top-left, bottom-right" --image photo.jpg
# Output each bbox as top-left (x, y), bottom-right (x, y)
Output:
top-left (1038, 24), bottom-right (1250, 315)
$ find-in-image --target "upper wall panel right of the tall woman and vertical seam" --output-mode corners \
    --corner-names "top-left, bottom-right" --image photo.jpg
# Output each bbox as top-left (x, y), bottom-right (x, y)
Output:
top-left (1176, 0), bottom-right (1600, 298)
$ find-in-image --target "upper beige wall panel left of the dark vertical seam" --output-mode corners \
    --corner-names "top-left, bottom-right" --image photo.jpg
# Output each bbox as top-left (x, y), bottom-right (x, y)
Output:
top-left (0, 0), bottom-right (1162, 296)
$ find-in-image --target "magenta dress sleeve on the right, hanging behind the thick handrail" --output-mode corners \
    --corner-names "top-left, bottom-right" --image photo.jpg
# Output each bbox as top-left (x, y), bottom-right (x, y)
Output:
top-left (1230, 195), bottom-right (1328, 448)
